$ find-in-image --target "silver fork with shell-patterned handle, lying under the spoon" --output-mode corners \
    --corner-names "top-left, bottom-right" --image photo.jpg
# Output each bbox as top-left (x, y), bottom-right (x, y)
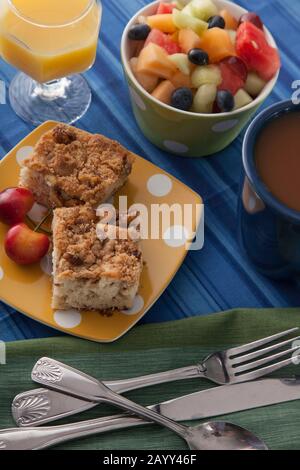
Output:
top-left (12, 328), bottom-right (300, 427)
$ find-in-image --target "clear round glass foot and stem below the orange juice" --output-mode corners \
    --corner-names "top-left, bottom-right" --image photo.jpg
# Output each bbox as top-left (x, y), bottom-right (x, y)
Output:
top-left (9, 73), bottom-right (92, 126)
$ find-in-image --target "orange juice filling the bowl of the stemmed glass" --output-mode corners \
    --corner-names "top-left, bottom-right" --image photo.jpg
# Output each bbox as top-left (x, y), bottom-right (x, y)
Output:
top-left (0, 0), bottom-right (101, 83)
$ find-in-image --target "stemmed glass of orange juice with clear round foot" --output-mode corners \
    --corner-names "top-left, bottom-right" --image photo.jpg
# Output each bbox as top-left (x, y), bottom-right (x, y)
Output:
top-left (0, 0), bottom-right (102, 125)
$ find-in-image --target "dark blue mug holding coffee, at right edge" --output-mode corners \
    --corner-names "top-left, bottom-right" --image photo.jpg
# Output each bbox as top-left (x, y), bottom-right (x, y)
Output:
top-left (238, 100), bottom-right (300, 279)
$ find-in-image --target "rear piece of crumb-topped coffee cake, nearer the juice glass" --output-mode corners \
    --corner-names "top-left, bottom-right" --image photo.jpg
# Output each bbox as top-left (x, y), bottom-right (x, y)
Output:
top-left (20, 124), bottom-right (134, 208)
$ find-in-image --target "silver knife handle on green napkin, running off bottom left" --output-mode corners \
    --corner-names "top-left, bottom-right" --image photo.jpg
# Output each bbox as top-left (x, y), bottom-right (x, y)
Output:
top-left (0, 414), bottom-right (151, 450)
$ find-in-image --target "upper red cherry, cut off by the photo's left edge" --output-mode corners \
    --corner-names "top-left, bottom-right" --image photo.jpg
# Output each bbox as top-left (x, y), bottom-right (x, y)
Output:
top-left (0, 188), bottom-right (34, 226)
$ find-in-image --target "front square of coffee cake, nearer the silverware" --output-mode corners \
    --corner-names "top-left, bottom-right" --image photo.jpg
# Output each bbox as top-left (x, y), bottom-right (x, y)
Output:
top-left (52, 206), bottom-right (143, 310)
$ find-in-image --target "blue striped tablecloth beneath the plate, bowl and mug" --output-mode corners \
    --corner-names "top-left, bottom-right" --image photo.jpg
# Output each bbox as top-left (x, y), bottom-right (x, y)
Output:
top-left (0, 0), bottom-right (300, 341)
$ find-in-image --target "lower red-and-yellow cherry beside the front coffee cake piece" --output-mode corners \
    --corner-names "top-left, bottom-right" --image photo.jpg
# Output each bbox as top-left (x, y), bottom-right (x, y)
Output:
top-left (4, 223), bottom-right (50, 265)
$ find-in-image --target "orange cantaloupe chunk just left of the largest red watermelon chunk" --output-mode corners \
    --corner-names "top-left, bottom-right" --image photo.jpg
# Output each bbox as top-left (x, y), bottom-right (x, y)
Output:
top-left (200, 28), bottom-right (236, 63)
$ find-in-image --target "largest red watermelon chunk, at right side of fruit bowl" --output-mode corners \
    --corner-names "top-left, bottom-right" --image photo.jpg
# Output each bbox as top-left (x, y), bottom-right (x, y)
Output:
top-left (236, 21), bottom-right (280, 81)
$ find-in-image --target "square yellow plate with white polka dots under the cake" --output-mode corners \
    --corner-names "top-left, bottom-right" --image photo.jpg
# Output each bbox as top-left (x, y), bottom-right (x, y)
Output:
top-left (0, 121), bottom-right (202, 342)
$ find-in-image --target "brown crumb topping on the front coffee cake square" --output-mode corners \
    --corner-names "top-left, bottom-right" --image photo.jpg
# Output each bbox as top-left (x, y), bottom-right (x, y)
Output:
top-left (53, 206), bottom-right (142, 285)
